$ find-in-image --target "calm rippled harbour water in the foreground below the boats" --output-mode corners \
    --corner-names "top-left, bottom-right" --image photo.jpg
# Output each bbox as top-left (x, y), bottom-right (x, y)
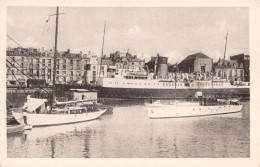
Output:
top-left (7, 100), bottom-right (250, 158)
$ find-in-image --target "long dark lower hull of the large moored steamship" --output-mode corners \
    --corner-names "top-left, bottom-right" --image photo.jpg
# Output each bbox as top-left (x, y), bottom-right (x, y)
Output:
top-left (98, 87), bottom-right (250, 99)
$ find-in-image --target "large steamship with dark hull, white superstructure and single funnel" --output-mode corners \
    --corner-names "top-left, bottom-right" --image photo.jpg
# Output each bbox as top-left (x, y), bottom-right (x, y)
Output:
top-left (98, 57), bottom-right (250, 98)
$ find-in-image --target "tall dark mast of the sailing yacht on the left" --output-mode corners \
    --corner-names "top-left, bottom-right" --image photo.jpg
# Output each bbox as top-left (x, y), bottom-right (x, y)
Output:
top-left (52, 6), bottom-right (59, 104)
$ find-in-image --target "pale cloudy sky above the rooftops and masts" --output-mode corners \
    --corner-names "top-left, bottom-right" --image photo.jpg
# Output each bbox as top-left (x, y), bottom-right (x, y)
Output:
top-left (6, 7), bottom-right (249, 64)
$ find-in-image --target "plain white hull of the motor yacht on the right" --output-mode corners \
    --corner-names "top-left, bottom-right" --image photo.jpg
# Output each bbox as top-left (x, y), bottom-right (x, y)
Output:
top-left (146, 104), bottom-right (242, 119)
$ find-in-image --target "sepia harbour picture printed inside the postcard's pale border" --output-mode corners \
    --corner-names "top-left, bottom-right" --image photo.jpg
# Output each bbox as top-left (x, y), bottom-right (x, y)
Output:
top-left (1, 0), bottom-right (260, 166)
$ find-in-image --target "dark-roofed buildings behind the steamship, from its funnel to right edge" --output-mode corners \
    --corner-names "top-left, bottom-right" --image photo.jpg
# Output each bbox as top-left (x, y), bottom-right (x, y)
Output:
top-left (146, 53), bottom-right (250, 83)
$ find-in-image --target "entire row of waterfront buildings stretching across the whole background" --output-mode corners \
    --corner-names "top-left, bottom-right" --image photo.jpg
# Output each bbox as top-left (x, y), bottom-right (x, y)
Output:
top-left (6, 47), bottom-right (250, 87)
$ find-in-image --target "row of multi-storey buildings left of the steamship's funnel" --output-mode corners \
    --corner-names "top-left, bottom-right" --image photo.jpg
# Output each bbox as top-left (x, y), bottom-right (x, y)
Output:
top-left (6, 47), bottom-right (145, 87)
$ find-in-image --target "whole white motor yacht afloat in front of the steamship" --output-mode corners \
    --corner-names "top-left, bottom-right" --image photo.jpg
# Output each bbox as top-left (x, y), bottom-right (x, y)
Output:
top-left (145, 99), bottom-right (242, 119)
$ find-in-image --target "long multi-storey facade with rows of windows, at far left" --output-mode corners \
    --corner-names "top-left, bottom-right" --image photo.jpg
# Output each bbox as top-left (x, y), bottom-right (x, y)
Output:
top-left (6, 47), bottom-right (84, 87)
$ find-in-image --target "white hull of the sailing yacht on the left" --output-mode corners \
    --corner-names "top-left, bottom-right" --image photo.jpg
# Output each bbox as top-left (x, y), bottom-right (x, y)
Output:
top-left (13, 109), bottom-right (107, 127)
